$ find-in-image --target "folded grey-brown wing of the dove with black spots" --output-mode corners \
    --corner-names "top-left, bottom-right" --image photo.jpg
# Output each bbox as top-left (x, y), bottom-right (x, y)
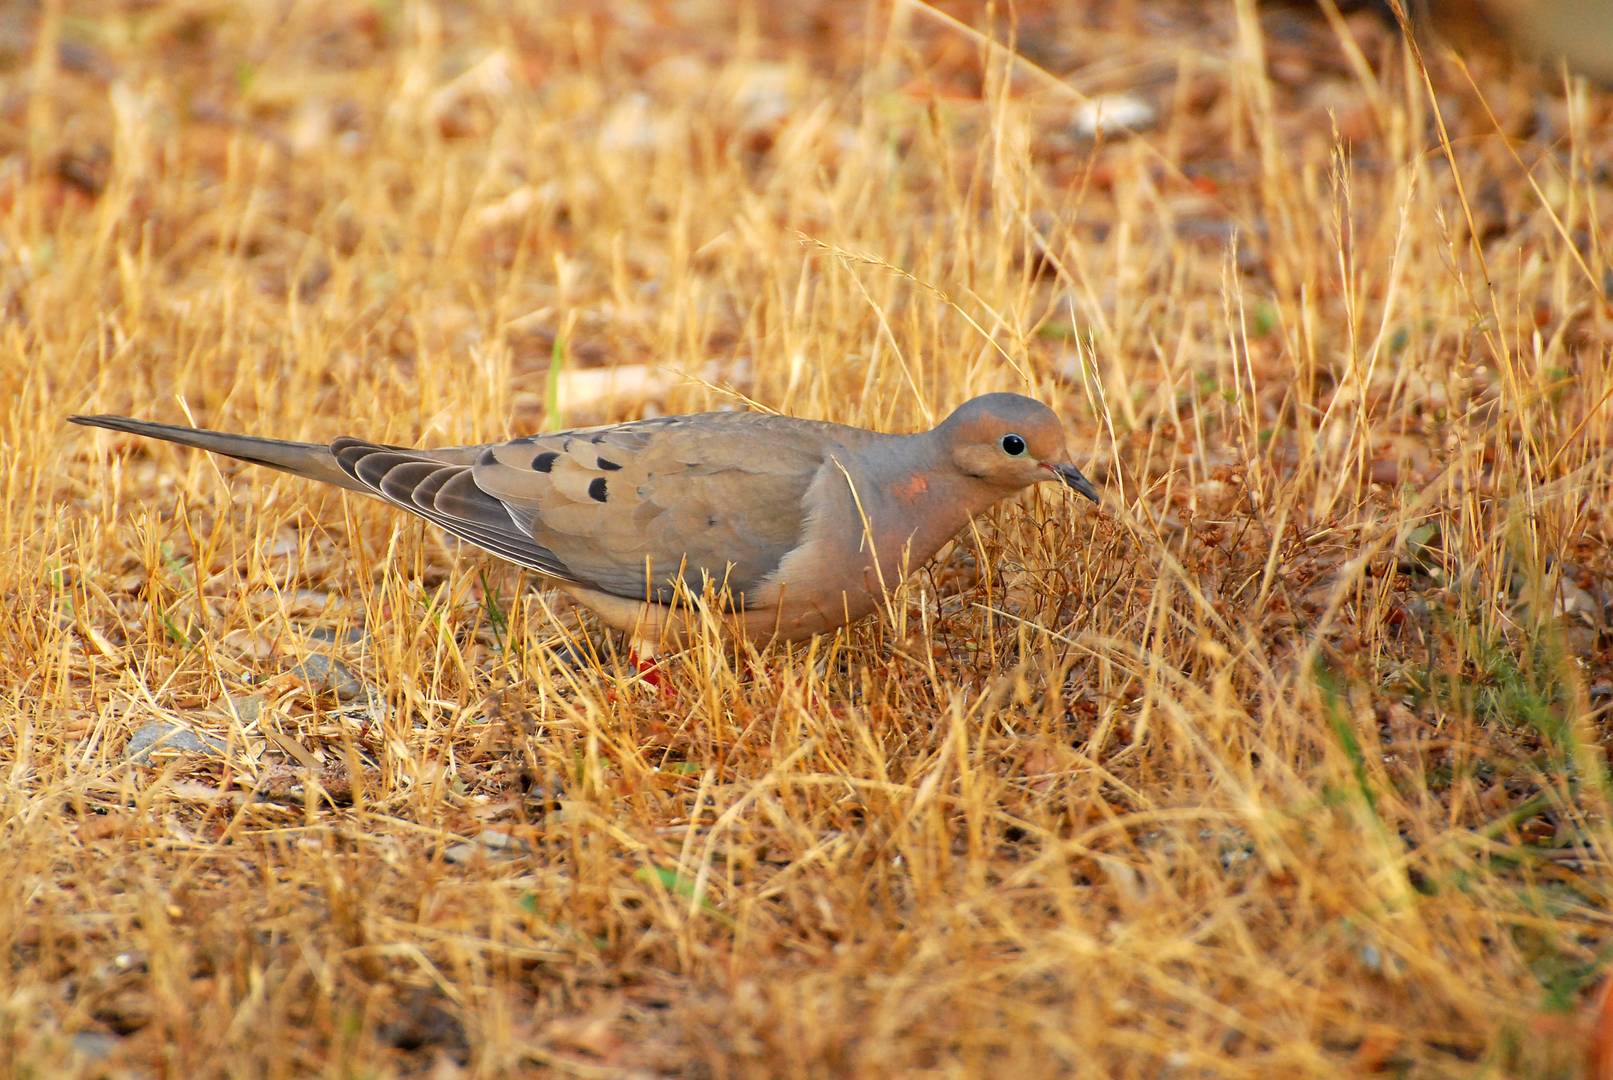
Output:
top-left (331, 413), bottom-right (876, 603)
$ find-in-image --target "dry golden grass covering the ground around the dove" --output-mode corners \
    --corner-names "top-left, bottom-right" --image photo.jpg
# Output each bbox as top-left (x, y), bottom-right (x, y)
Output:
top-left (0, 0), bottom-right (1613, 1077)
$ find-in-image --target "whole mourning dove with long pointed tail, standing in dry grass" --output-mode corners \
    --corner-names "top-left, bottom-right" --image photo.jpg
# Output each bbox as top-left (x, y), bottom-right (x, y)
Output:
top-left (71, 393), bottom-right (1098, 656)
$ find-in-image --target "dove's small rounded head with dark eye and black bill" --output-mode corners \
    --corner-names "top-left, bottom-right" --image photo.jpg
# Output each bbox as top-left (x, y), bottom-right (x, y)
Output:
top-left (936, 393), bottom-right (1098, 503)
